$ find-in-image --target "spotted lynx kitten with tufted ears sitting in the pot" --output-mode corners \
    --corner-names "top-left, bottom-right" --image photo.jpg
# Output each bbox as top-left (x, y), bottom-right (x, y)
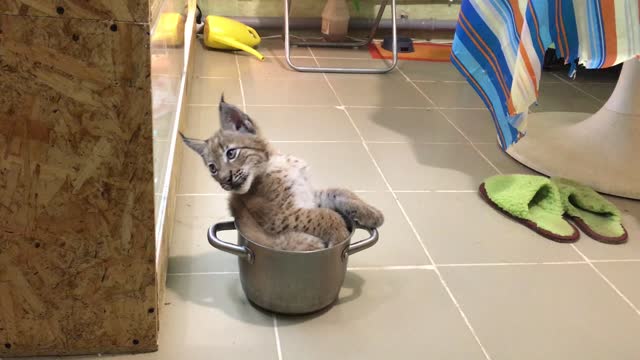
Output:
top-left (181, 97), bottom-right (384, 251)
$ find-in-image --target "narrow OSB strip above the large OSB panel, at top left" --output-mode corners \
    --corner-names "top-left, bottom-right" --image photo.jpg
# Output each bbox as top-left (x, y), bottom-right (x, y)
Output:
top-left (0, 0), bottom-right (149, 23)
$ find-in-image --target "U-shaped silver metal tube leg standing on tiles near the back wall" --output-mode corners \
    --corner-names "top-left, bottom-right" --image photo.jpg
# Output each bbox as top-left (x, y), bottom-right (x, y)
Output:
top-left (284, 0), bottom-right (398, 74)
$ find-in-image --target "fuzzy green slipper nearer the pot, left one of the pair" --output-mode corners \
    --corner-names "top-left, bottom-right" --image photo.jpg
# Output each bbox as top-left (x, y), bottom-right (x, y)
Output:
top-left (479, 175), bottom-right (580, 242)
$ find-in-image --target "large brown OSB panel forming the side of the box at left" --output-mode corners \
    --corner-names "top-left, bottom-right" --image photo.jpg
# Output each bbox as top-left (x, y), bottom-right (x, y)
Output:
top-left (0, 15), bottom-right (157, 357)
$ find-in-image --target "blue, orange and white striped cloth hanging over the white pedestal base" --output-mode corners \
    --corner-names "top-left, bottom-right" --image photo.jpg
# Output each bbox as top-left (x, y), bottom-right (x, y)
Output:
top-left (451, 0), bottom-right (640, 149)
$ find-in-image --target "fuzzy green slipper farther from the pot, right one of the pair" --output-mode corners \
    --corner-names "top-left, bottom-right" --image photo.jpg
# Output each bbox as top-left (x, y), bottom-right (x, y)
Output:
top-left (551, 178), bottom-right (628, 244)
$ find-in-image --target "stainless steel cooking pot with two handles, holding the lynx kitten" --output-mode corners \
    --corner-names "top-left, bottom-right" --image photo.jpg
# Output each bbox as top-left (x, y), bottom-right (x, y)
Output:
top-left (208, 221), bottom-right (378, 314)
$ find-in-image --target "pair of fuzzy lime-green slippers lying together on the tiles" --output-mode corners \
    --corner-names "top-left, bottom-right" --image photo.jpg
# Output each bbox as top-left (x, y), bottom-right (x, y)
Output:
top-left (479, 175), bottom-right (628, 244)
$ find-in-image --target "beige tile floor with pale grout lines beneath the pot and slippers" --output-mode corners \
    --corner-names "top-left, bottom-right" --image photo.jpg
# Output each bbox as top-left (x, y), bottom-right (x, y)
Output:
top-left (86, 40), bottom-right (640, 360)
